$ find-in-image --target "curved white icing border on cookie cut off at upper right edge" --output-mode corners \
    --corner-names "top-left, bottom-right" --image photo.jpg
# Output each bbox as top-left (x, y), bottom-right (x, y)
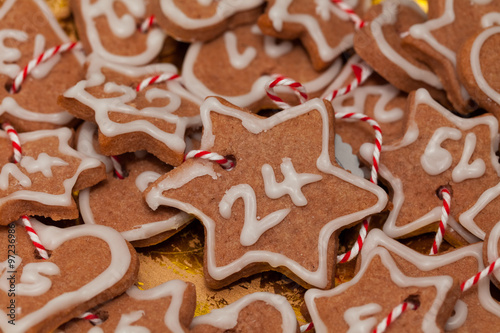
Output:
top-left (470, 25), bottom-right (500, 104)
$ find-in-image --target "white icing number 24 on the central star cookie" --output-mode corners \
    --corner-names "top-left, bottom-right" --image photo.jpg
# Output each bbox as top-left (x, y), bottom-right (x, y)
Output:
top-left (219, 158), bottom-right (323, 246)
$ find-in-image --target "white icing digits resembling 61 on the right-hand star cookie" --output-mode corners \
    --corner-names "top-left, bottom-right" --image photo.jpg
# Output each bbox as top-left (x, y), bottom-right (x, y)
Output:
top-left (420, 127), bottom-right (486, 183)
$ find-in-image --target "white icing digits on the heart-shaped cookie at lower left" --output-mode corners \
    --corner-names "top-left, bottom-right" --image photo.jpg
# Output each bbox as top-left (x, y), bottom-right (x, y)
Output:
top-left (0, 255), bottom-right (61, 297)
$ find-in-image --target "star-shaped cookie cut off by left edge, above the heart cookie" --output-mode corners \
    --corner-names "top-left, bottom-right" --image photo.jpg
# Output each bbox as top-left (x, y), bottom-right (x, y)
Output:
top-left (0, 128), bottom-right (105, 225)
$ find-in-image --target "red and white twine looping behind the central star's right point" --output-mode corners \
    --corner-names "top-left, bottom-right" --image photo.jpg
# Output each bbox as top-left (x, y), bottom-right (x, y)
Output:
top-left (335, 113), bottom-right (382, 263)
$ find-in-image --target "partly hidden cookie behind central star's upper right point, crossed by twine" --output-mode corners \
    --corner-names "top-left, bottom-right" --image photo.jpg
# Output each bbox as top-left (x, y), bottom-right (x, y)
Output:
top-left (322, 55), bottom-right (407, 154)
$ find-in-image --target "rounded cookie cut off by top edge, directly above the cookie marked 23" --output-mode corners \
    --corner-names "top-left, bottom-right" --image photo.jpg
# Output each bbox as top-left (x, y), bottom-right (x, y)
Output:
top-left (70, 0), bottom-right (165, 66)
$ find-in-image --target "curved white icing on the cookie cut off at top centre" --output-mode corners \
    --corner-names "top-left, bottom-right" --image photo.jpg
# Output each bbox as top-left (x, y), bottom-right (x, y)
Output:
top-left (160, 0), bottom-right (264, 30)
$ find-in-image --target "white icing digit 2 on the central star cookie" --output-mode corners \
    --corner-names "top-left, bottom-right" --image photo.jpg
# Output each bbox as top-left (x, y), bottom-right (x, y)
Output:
top-left (219, 184), bottom-right (290, 246)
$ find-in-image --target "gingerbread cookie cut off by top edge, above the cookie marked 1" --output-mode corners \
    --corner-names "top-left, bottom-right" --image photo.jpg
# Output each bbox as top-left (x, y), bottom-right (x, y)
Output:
top-left (152, 0), bottom-right (264, 42)
